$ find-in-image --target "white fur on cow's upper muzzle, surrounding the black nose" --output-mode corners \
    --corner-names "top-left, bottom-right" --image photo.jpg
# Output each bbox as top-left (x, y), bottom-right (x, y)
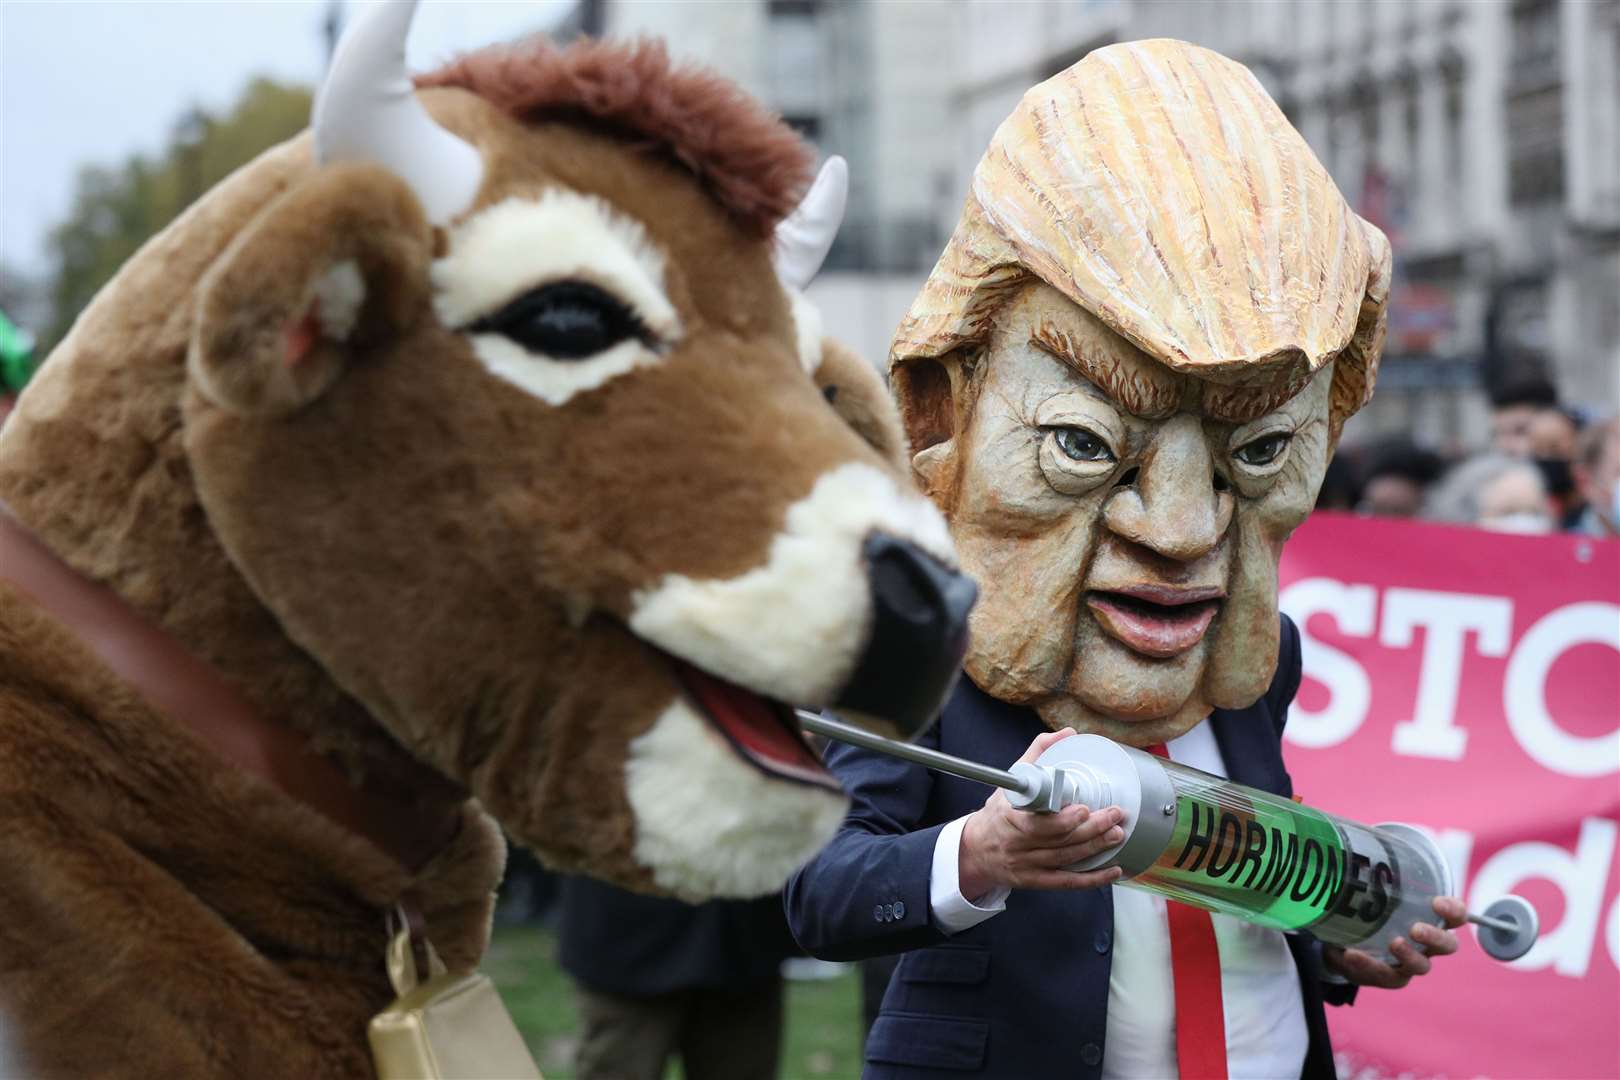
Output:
top-left (630, 461), bottom-right (956, 706)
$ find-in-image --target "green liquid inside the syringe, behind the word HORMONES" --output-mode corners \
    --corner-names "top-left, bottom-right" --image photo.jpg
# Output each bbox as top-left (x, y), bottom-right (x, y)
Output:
top-left (1126, 774), bottom-right (1367, 929)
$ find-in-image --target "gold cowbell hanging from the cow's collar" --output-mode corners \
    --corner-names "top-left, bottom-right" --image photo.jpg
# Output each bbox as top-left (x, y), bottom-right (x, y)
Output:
top-left (368, 918), bottom-right (541, 1080)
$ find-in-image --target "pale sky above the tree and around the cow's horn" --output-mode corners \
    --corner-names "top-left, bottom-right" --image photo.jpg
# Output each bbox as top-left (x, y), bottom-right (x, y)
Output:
top-left (0, 0), bottom-right (572, 275)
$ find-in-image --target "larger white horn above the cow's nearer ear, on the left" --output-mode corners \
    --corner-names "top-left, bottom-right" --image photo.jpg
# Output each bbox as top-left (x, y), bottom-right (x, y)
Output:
top-left (313, 0), bottom-right (484, 225)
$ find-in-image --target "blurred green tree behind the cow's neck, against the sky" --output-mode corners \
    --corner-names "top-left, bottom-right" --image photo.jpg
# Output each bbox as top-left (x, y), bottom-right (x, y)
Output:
top-left (41, 78), bottom-right (311, 355)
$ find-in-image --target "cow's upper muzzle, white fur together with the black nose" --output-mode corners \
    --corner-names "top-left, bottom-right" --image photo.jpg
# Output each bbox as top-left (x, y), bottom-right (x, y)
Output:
top-left (629, 461), bottom-right (977, 738)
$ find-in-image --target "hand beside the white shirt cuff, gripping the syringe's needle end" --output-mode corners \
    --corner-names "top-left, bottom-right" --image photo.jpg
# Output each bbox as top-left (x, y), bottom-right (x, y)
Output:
top-left (957, 727), bottom-right (1124, 900)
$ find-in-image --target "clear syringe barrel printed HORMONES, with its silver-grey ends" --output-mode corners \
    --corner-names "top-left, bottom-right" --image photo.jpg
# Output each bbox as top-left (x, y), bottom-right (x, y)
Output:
top-left (1038, 735), bottom-right (1453, 955)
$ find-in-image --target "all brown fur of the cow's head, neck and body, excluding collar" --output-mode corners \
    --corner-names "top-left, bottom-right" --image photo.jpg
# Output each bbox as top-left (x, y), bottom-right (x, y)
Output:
top-left (0, 40), bottom-right (897, 1077)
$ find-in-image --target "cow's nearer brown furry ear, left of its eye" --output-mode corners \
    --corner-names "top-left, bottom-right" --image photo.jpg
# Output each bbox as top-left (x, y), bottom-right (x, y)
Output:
top-left (188, 164), bottom-right (433, 415)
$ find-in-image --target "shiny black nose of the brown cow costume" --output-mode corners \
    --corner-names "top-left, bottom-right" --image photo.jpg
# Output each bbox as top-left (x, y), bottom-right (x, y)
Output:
top-left (834, 533), bottom-right (978, 738)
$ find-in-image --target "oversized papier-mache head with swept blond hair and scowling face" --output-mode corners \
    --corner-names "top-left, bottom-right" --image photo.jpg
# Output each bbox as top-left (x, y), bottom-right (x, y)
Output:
top-left (891, 40), bottom-right (1390, 743)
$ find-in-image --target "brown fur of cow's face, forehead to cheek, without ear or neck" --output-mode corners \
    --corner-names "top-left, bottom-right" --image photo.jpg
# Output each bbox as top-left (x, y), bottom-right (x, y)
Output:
top-left (186, 91), bottom-right (894, 887)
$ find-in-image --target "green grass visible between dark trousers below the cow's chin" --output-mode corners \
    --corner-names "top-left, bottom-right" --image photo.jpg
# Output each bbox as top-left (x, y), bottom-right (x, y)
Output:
top-left (483, 926), bottom-right (860, 1080)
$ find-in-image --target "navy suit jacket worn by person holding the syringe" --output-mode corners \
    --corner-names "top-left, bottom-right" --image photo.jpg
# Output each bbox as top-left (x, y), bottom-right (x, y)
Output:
top-left (786, 617), bottom-right (1353, 1080)
